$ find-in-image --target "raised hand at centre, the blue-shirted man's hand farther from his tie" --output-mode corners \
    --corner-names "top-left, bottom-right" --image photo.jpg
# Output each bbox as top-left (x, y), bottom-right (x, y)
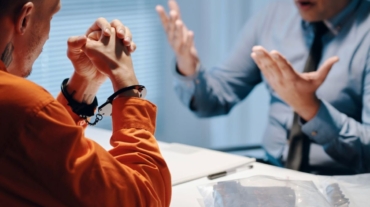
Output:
top-left (156, 0), bottom-right (199, 76)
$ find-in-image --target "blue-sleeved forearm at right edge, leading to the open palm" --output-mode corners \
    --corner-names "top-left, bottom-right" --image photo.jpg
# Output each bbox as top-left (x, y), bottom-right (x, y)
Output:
top-left (302, 101), bottom-right (370, 173)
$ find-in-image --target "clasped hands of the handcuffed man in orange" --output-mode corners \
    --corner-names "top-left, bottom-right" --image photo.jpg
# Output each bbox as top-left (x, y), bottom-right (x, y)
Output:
top-left (67, 18), bottom-right (138, 103)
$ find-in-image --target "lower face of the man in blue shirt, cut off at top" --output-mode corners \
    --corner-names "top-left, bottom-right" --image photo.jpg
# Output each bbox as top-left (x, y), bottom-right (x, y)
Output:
top-left (294, 0), bottom-right (351, 22)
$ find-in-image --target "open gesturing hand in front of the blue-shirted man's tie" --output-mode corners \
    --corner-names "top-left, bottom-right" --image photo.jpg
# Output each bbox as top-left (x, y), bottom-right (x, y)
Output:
top-left (251, 46), bottom-right (339, 121)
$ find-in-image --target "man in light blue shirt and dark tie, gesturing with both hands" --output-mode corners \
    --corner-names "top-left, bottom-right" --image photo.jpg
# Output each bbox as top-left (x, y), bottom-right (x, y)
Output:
top-left (156, 0), bottom-right (370, 174)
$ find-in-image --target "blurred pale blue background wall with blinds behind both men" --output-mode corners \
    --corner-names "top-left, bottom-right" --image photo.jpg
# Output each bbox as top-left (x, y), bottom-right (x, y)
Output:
top-left (30, 0), bottom-right (273, 148)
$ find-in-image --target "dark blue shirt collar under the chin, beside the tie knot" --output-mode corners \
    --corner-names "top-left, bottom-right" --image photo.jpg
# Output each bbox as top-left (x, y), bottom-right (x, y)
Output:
top-left (302, 0), bottom-right (362, 35)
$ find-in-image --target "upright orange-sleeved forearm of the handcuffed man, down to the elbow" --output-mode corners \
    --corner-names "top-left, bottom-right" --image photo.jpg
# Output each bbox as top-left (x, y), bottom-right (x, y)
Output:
top-left (109, 98), bottom-right (172, 206)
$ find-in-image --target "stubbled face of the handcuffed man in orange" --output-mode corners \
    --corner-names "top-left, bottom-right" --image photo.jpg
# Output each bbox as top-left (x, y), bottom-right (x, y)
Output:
top-left (7, 0), bottom-right (61, 77)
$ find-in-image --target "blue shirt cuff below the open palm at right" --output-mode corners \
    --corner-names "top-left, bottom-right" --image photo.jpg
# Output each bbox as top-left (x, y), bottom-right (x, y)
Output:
top-left (302, 100), bottom-right (345, 145)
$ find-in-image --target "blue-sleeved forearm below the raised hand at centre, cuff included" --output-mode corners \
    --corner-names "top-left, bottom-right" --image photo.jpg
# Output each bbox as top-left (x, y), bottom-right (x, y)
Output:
top-left (175, 62), bottom-right (261, 117)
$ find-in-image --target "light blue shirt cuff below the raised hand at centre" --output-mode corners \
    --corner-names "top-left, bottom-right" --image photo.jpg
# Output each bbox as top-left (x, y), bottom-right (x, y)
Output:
top-left (174, 61), bottom-right (204, 107)
